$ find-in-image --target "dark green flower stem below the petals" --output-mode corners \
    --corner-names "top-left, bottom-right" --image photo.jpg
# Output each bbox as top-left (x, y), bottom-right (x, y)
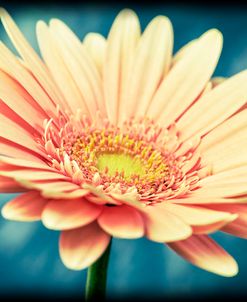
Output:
top-left (85, 241), bottom-right (111, 302)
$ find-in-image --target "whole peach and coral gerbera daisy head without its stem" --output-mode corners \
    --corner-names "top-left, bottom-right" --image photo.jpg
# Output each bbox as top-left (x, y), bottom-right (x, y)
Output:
top-left (0, 10), bottom-right (247, 276)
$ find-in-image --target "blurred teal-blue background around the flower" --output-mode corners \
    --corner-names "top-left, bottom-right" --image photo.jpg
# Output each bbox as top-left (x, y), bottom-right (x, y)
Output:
top-left (0, 1), bottom-right (247, 300)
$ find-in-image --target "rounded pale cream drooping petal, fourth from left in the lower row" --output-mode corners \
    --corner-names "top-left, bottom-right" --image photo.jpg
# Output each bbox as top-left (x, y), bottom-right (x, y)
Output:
top-left (142, 206), bottom-right (192, 242)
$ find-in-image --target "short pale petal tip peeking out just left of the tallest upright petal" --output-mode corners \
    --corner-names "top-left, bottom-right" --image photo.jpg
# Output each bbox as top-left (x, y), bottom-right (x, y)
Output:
top-left (83, 33), bottom-right (107, 76)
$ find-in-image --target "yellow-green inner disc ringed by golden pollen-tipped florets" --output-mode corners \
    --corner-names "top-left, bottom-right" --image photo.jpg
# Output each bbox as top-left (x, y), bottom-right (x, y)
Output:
top-left (71, 129), bottom-right (167, 185)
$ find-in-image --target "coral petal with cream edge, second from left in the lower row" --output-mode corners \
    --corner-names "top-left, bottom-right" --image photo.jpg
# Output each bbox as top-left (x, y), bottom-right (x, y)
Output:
top-left (42, 198), bottom-right (102, 230)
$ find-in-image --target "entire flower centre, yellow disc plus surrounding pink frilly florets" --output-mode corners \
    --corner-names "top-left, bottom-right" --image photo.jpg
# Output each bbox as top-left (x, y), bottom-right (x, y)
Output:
top-left (44, 113), bottom-right (202, 203)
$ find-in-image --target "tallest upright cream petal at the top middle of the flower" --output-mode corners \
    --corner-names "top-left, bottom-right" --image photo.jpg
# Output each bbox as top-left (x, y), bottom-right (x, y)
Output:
top-left (103, 10), bottom-right (140, 124)
